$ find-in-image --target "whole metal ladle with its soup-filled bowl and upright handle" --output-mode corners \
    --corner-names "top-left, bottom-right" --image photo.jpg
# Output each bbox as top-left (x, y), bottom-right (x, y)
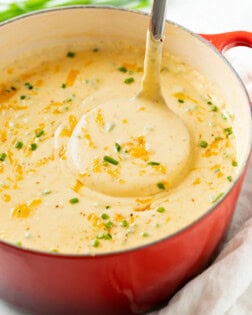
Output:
top-left (67, 0), bottom-right (191, 197)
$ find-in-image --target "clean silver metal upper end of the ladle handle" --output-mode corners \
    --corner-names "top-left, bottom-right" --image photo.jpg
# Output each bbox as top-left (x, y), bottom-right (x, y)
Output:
top-left (150, 0), bottom-right (168, 40)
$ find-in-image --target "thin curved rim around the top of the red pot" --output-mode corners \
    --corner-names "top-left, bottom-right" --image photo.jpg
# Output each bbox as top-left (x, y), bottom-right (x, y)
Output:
top-left (0, 5), bottom-right (252, 259)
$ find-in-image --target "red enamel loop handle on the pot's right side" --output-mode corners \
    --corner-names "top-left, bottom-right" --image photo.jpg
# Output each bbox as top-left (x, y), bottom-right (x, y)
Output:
top-left (200, 31), bottom-right (252, 107)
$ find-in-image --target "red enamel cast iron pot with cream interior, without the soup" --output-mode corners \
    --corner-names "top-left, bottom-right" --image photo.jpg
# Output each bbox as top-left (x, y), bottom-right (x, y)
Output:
top-left (0, 7), bottom-right (252, 315)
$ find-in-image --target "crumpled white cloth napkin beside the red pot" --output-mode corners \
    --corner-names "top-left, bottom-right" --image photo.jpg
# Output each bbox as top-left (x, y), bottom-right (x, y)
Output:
top-left (149, 48), bottom-right (252, 315)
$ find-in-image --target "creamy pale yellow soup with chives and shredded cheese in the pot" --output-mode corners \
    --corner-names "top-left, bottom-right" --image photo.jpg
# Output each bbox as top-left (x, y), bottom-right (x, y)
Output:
top-left (0, 40), bottom-right (237, 254)
